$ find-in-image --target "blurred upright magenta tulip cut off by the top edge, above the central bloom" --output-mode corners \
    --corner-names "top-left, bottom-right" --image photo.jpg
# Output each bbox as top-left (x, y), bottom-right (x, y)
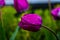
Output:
top-left (14, 0), bottom-right (29, 12)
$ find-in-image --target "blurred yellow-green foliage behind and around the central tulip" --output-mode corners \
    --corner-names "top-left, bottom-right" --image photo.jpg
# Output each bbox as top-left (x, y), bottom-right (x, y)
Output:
top-left (0, 3), bottom-right (60, 40)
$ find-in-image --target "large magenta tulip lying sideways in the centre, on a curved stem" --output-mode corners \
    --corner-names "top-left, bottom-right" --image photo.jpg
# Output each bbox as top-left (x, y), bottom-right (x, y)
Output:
top-left (19, 14), bottom-right (42, 32)
